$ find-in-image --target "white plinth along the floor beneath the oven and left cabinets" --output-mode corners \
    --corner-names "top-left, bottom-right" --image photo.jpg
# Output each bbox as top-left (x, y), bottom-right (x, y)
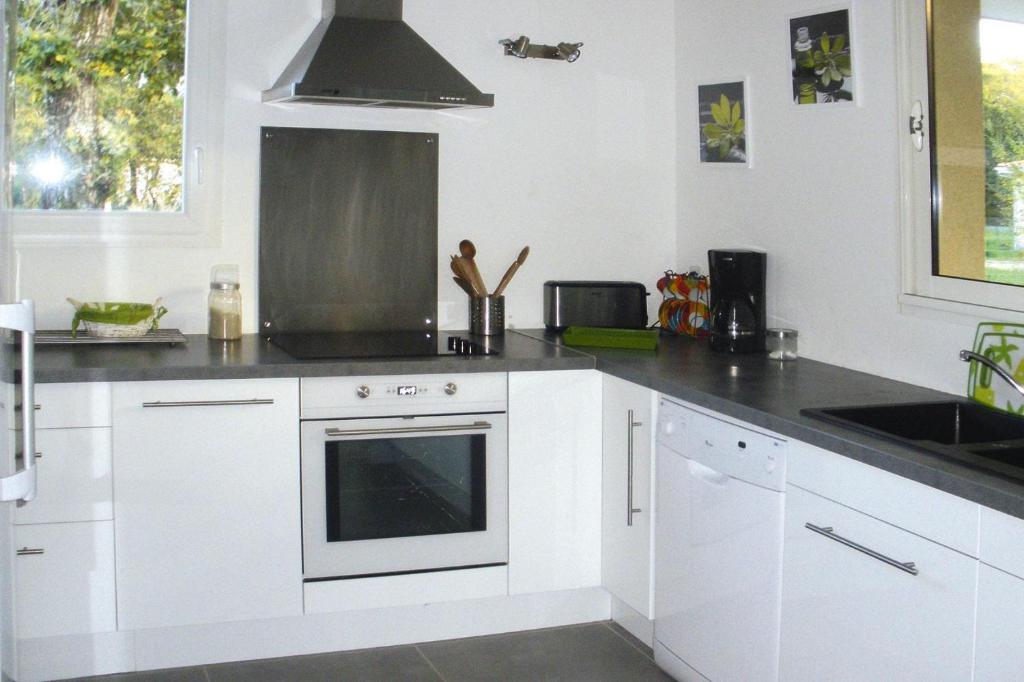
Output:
top-left (18, 588), bottom-right (611, 682)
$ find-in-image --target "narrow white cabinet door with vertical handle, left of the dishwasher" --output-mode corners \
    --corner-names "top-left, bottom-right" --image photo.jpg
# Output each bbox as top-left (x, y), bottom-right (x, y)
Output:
top-left (601, 375), bottom-right (657, 619)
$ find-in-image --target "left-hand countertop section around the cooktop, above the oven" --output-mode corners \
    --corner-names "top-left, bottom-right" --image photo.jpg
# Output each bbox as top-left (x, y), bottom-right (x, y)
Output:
top-left (29, 332), bottom-right (595, 383)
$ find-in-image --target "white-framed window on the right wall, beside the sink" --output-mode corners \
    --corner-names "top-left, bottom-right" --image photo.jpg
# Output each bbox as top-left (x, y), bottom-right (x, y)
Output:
top-left (901, 0), bottom-right (1024, 314)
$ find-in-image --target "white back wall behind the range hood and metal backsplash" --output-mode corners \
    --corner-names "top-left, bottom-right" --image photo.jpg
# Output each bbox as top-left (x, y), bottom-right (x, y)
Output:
top-left (19, 0), bottom-right (676, 332)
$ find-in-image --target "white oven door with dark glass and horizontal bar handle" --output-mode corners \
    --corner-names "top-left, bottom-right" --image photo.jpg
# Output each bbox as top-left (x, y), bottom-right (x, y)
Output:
top-left (302, 414), bottom-right (508, 579)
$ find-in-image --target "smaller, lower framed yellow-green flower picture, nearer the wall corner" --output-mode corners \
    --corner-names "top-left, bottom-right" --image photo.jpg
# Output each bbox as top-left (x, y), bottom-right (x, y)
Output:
top-left (697, 80), bottom-right (751, 167)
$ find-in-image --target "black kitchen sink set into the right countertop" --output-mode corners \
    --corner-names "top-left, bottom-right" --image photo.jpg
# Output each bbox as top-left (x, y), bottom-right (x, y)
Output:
top-left (800, 400), bottom-right (1024, 482)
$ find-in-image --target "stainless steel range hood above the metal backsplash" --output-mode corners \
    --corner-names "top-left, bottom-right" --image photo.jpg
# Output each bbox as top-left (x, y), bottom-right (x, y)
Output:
top-left (263, 0), bottom-right (495, 109)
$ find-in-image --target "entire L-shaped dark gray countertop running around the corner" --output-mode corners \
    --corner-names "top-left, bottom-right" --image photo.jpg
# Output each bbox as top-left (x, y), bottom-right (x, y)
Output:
top-left (25, 330), bottom-right (1024, 518)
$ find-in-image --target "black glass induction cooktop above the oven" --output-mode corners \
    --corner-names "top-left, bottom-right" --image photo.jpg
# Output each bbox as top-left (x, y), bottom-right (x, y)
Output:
top-left (270, 332), bottom-right (498, 359)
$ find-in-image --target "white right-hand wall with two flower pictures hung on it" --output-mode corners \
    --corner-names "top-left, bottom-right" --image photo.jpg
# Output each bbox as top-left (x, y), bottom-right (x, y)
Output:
top-left (677, 0), bottom-right (978, 393)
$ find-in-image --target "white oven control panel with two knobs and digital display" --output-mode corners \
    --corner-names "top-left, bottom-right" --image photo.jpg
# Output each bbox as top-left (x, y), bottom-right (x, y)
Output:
top-left (301, 372), bottom-right (508, 419)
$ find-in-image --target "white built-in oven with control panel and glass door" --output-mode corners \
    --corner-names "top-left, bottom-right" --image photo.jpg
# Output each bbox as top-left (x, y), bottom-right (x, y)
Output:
top-left (301, 374), bottom-right (508, 581)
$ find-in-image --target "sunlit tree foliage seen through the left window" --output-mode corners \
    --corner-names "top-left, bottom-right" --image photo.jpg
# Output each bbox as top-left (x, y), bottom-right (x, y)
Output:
top-left (12, 0), bottom-right (186, 211)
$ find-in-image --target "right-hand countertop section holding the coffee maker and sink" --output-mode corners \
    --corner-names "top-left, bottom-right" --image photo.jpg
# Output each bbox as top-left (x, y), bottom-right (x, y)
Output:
top-left (520, 330), bottom-right (1024, 518)
